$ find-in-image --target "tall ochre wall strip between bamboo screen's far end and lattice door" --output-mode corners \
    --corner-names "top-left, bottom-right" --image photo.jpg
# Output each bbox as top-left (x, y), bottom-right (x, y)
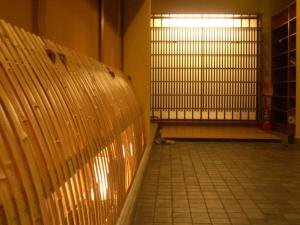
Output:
top-left (123, 0), bottom-right (151, 142)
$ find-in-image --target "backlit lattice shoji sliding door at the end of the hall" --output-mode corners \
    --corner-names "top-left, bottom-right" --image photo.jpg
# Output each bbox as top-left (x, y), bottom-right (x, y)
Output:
top-left (151, 14), bottom-right (261, 120)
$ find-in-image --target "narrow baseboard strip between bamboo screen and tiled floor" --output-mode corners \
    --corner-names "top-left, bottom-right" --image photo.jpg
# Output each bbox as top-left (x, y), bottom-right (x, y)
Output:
top-left (116, 143), bottom-right (152, 225)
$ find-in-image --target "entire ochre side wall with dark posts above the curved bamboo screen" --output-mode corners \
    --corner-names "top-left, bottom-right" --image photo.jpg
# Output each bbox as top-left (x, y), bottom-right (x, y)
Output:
top-left (0, 0), bottom-right (122, 69)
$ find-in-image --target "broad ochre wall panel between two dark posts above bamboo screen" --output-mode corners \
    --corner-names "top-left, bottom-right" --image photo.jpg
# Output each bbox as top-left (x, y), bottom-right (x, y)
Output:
top-left (38, 0), bottom-right (99, 59)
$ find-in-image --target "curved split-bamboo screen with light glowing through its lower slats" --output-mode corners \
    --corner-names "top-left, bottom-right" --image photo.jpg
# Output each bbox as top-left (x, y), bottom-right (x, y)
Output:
top-left (0, 21), bottom-right (144, 225)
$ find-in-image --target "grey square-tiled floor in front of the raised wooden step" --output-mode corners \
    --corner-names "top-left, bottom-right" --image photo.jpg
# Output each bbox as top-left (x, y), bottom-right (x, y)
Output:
top-left (133, 142), bottom-right (300, 225)
